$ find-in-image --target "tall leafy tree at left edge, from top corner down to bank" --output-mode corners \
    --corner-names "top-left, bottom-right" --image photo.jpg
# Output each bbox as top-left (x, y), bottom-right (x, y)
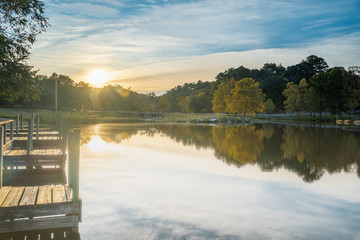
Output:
top-left (0, 0), bottom-right (48, 105)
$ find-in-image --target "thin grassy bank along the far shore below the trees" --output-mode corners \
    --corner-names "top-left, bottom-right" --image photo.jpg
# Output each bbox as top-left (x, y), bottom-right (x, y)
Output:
top-left (0, 108), bottom-right (356, 124)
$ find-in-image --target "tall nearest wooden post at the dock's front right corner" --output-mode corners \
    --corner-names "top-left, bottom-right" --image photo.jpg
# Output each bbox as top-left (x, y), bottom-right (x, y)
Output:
top-left (68, 130), bottom-right (80, 202)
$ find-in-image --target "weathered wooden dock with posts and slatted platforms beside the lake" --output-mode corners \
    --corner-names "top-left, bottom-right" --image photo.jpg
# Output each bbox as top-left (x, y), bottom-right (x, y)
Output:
top-left (0, 116), bottom-right (82, 239)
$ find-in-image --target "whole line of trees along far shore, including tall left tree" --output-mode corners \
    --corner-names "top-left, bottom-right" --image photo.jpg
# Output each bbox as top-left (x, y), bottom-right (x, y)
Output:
top-left (0, 0), bottom-right (360, 114)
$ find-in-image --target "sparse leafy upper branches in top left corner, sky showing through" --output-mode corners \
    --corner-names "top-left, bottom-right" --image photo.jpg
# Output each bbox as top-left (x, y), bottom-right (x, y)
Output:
top-left (0, 0), bottom-right (49, 62)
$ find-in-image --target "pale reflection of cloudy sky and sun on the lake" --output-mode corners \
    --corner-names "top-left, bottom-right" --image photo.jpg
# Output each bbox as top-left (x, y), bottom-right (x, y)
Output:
top-left (80, 128), bottom-right (360, 239)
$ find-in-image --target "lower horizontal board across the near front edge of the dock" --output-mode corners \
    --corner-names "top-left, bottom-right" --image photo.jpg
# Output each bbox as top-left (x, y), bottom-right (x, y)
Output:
top-left (0, 216), bottom-right (79, 233)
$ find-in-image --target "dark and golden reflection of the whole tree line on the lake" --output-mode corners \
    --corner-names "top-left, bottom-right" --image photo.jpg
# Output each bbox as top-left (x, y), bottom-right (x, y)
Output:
top-left (82, 124), bottom-right (360, 182)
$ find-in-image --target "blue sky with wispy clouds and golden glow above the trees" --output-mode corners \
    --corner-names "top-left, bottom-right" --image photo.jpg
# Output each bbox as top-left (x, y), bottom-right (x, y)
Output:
top-left (28, 0), bottom-right (360, 94)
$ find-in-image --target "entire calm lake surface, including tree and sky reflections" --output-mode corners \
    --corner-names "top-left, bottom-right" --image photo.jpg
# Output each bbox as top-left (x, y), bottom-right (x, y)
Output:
top-left (80, 124), bottom-right (360, 239)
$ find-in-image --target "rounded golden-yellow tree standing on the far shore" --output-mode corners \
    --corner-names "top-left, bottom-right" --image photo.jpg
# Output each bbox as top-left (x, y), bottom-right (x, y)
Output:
top-left (225, 78), bottom-right (265, 115)
